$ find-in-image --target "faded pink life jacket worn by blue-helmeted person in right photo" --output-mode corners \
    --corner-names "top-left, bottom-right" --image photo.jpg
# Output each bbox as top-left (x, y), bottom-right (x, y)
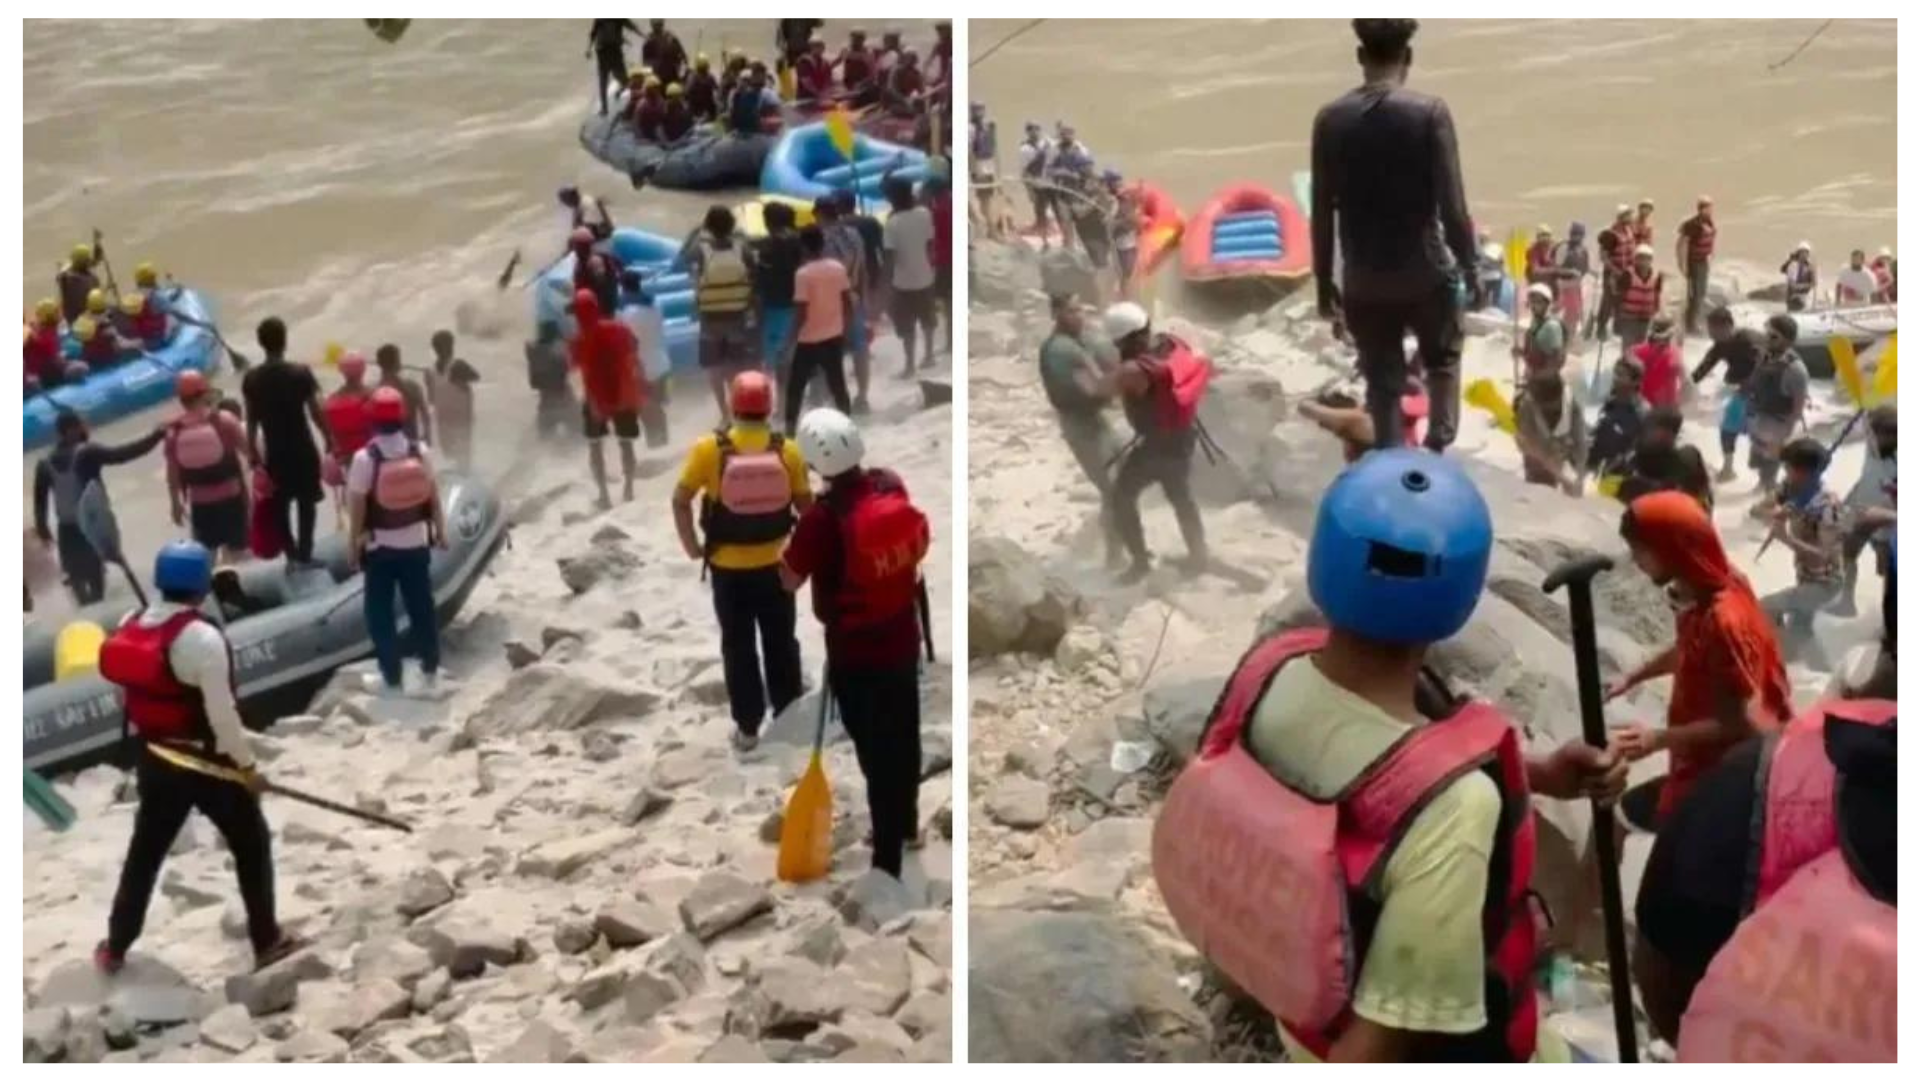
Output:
top-left (1154, 628), bottom-right (1540, 1061)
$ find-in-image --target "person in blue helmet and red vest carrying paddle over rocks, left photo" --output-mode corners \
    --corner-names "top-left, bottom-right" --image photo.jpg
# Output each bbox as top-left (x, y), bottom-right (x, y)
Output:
top-left (94, 540), bottom-right (305, 974)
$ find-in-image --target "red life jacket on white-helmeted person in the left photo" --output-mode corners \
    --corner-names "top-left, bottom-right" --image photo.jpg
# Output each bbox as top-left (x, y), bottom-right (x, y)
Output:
top-left (831, 469), bottom-right (933, 630)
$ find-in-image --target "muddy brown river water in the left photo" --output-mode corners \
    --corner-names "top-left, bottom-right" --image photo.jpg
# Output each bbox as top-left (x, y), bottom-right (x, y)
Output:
top-left (21, 19), bottom-right (933, 603)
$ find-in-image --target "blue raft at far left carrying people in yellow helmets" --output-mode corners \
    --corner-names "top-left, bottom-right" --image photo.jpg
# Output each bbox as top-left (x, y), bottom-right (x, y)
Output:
top-left (21, 288), bottom-right (221, 452)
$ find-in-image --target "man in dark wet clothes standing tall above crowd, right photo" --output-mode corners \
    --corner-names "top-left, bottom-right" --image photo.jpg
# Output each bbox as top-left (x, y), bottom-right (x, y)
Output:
top-left (1311, 19), bottom-right (1478, 452)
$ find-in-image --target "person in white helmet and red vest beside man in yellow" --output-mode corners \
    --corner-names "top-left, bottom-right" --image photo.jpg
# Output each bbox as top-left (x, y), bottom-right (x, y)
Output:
top-left (780, 409), bottom-right (933, 878)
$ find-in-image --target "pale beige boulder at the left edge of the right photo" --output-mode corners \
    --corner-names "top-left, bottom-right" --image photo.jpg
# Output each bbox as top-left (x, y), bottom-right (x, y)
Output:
top-left (966, 534), bottom-right (1079, 659)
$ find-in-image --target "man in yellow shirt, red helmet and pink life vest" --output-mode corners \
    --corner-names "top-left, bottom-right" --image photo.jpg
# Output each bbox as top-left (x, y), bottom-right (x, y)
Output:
top-left (674, 371), bottom-right (814, 751)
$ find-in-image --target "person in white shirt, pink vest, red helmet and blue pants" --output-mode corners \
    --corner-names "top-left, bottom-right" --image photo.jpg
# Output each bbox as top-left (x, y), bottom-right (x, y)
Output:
top-left (348, 386), bottom-right (447, 696)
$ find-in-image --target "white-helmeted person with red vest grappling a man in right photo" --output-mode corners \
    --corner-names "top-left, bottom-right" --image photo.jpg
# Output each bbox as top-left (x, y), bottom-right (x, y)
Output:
top-left (1106, 304), bottom-right (1205, 582)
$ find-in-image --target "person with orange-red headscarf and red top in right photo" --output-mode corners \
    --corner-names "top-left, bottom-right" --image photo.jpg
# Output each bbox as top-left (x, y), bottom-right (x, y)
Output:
top-left (1607, 492), bottom-right (1793, 821)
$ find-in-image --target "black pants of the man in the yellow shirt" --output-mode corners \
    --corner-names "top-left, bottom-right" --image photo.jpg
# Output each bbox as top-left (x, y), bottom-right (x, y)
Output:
top-left (712, 567), bottom-right (801, 734)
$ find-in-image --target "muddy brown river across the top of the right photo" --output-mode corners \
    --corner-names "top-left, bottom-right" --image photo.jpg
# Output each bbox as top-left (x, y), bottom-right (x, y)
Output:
top-left (968, 19), bottom-right (1897, 270)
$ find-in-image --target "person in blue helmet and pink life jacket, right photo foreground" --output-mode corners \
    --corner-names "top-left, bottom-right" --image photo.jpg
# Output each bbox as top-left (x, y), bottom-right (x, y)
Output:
top-left (1156, 448), bottom-right (1626, 1061)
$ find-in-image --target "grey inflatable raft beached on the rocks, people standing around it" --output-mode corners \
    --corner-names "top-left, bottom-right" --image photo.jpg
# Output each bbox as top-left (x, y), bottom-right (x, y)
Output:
top-left (21, 477), bottom-right (507, 773)
